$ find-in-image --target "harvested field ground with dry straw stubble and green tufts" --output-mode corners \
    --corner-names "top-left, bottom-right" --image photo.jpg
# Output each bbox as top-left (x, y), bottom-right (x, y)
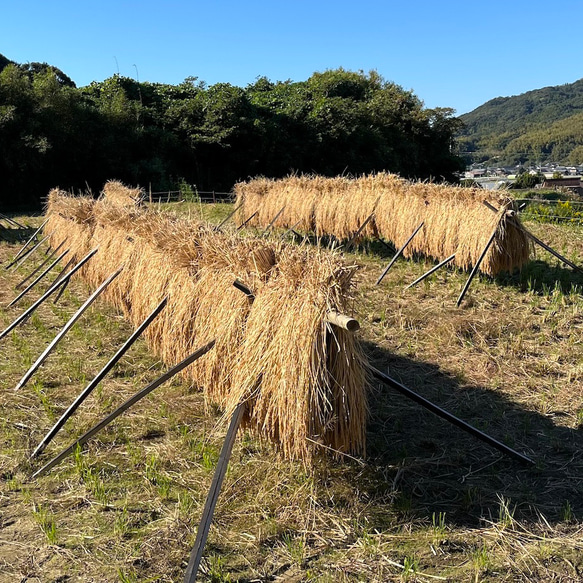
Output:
top-left (0, 210), bottom-right (583, 583)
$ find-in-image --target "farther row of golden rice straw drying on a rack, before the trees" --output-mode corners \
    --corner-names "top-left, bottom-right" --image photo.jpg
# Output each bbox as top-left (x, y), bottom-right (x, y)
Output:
top-left (235, 173), bottom-right (530, 275)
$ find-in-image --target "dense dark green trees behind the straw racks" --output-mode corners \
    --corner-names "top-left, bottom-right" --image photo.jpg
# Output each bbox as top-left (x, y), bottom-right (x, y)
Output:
top-left (0, 55), bottom-right (462, 208)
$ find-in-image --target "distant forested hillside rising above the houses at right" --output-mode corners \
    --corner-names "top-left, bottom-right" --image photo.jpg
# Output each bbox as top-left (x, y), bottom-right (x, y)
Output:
top-left (459, 79), bottom-right (583, 165)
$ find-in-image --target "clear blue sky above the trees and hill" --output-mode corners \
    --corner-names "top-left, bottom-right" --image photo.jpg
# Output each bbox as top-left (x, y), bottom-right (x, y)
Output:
top-left (0, 0), bottom-right (583, 114)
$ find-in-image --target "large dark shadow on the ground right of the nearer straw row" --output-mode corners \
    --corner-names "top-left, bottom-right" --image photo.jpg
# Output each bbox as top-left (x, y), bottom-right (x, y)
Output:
top-left (356, 343), bottom-right (583, 528)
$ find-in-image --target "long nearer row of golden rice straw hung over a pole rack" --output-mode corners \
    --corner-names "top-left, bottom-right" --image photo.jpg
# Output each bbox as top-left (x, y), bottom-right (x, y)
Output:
top-left (48, 187), bottom-right (366, 460)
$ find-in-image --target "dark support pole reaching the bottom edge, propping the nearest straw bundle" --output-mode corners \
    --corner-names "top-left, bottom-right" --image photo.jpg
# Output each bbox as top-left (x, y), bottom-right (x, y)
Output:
top-left (184, 403), bottom-right (246, 583)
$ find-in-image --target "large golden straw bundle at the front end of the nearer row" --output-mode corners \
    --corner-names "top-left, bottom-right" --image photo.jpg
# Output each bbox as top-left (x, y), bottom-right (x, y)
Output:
top-left (226, 247), bottom-right (366, 460)
